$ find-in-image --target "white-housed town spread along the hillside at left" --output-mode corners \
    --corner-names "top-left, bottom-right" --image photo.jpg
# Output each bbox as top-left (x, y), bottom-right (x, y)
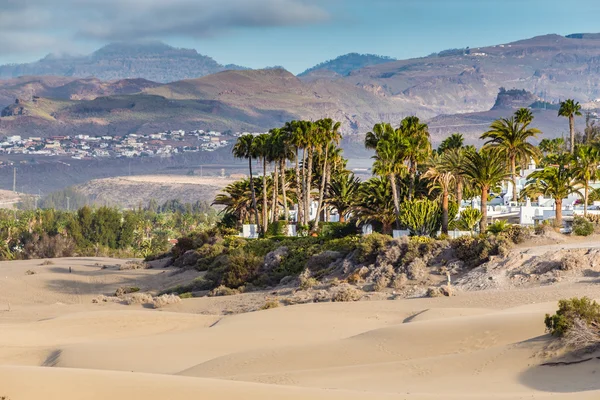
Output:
top-left (0, 130), bottom-right (258, 160)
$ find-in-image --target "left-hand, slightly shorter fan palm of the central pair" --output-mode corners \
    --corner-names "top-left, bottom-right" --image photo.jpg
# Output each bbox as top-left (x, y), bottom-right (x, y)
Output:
top-left (373, 130), bottom-right (408, 227)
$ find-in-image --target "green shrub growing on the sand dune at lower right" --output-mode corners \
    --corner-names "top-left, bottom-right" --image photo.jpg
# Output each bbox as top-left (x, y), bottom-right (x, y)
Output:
top-left (544, 297), bottom-right (600, 337)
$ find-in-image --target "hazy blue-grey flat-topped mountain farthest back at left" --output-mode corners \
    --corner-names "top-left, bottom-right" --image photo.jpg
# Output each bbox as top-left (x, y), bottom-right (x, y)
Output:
top-left (0, 41), bottom-right (246, 82)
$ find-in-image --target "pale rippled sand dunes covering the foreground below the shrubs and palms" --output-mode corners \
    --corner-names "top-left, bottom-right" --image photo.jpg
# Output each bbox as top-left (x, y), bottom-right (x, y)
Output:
top-left (0, 258), bottom-right (600, 400)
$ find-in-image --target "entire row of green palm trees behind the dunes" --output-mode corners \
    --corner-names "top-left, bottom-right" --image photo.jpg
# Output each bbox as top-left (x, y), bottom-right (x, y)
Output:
top-left (223, 100), bottom-right (600, 238)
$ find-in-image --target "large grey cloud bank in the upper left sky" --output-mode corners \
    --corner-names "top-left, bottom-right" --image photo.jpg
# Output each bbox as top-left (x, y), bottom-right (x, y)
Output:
top-left (0, 0), bottom-right (329, 53)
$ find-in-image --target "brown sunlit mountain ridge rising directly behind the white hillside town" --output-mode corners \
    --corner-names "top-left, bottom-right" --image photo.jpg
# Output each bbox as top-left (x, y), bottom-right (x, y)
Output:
top-left (0, 69), bottom-right (408, 136)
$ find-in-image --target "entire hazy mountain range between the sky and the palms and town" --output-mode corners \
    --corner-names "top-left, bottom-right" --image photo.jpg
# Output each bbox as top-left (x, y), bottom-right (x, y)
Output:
top-left (0, 34), bottom-right (600, 141)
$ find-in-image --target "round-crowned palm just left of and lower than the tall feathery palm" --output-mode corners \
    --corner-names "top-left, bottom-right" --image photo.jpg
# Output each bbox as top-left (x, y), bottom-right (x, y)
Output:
top-left (463, 149), bottom-right (510, 232)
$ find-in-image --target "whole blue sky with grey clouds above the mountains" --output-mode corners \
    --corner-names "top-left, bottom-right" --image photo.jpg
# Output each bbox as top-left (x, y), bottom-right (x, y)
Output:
top-left (0, 0), bottom-right (600, 73)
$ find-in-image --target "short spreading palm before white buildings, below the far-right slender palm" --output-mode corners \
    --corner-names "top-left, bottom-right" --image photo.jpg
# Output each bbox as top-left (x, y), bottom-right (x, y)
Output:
top-left (523, 164), bottom-right (581, 227)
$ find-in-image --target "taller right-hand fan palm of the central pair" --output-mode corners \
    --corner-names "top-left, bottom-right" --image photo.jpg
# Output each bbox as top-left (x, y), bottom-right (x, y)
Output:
top-left (398, 116), bottom-right (431, 200)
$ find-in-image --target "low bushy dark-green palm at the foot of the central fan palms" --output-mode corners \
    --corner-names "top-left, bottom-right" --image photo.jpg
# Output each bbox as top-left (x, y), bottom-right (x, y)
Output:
top-left (356, 177), bottom-right (398, 234)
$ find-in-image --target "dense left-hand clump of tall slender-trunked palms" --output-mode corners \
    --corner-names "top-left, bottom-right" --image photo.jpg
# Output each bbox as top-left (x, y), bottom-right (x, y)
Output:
top-left (224, 118), bottom-right (345, 234)
